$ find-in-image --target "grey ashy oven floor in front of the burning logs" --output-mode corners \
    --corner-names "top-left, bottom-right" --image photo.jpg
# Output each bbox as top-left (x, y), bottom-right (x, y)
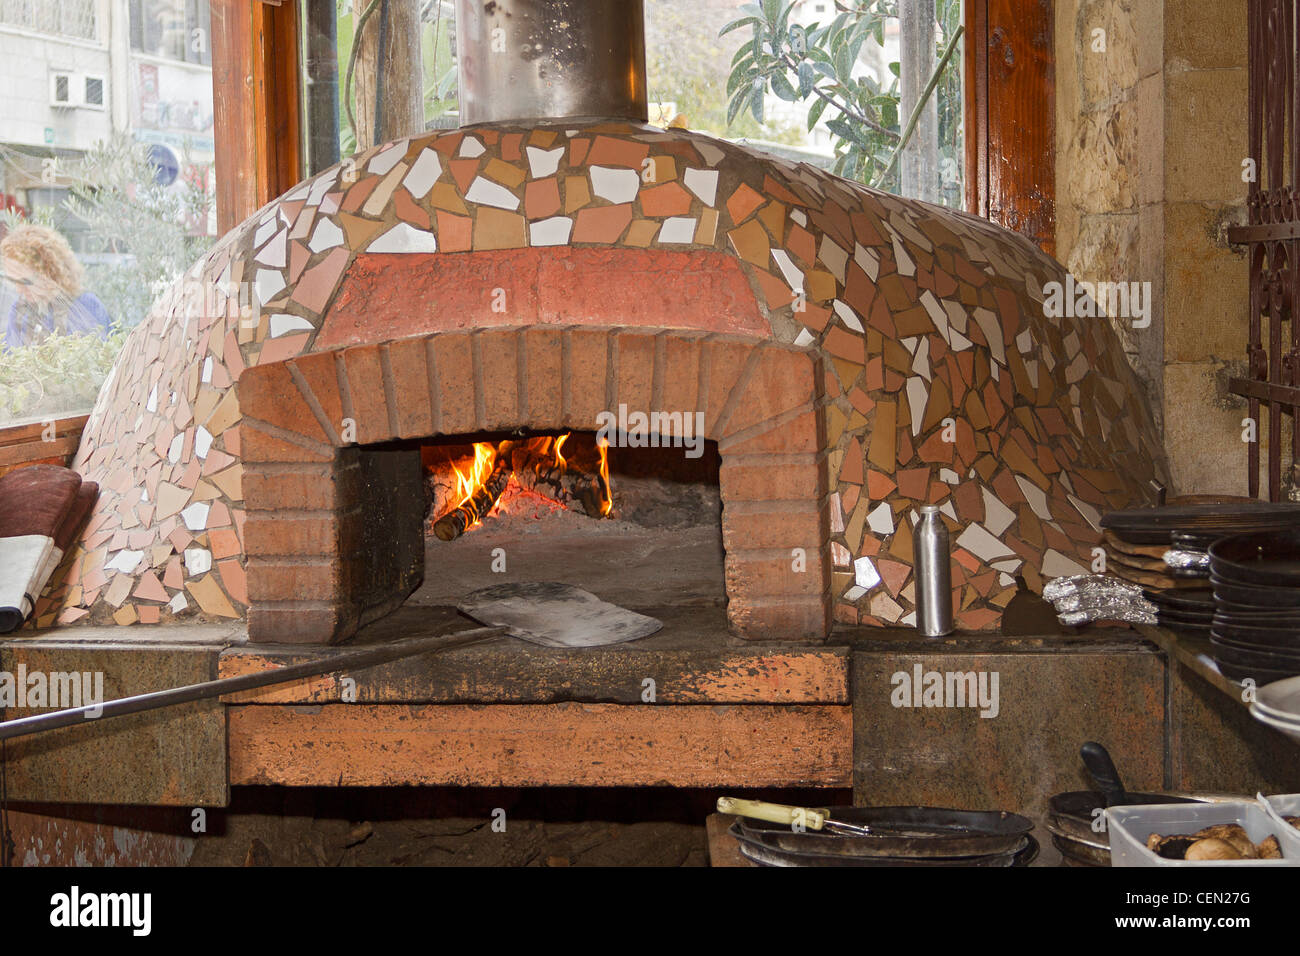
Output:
top-left (407, 515), bottom-right (725, 607)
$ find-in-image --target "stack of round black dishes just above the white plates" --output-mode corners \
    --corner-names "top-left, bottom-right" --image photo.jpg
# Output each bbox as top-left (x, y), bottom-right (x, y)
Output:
top-left (1209, 531), bottom-right (1300, 684)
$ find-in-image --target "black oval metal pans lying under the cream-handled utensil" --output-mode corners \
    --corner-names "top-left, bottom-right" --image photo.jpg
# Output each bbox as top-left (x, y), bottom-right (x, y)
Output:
top-left (736, 806), bottom-right (1034, 860)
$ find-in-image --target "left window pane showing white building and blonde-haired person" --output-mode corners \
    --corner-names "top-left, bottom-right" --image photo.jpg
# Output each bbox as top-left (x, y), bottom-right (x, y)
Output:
top-left (0, 0), bottom-right (216, 425)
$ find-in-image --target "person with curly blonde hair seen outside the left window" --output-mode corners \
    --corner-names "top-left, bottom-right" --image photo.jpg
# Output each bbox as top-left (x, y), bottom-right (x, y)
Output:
top-left (0, 224), bottom-right (112, 349)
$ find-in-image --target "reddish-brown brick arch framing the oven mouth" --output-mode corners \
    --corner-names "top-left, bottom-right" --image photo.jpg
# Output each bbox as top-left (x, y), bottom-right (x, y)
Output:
top-left (237, 328), bottom-right (831, 643)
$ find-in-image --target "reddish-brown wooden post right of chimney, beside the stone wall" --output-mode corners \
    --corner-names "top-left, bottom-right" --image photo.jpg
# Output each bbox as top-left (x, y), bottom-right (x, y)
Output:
top-left (963, 0), bottom-right (1056, 254)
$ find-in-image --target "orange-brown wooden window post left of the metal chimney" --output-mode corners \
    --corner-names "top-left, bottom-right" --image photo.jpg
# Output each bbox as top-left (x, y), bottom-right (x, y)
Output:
top-left (212, 0), bottom-right (303, 233)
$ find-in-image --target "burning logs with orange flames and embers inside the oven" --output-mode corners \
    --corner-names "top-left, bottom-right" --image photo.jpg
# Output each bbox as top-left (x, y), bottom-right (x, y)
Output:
top-left (424, 432), bottom-right (614, 541)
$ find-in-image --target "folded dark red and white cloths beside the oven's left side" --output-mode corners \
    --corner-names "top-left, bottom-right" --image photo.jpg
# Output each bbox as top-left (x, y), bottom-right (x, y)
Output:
top-left (0, 464), bottom-right (99, 633)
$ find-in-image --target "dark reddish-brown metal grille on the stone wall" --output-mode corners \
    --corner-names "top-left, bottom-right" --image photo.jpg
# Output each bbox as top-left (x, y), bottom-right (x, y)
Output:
top-left (1229, 0), bottom-right (1300, 501)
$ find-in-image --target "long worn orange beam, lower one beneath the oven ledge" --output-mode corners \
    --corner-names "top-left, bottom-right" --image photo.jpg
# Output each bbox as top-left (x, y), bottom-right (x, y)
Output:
top-left (226, 704), bottom-right (853, 787)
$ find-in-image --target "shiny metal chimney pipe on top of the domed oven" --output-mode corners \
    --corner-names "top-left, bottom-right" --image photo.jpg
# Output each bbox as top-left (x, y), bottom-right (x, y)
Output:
top-left (456, 0), bottom-right (649, 126)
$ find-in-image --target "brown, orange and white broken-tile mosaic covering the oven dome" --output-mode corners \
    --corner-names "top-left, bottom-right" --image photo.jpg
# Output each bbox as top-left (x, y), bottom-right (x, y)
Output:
top-left (36, 124), bottom-right (1166, 639)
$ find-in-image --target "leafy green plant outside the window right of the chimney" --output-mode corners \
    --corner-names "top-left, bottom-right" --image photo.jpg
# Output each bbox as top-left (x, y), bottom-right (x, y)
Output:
top-left (722, 0), bottom-right (962, 197)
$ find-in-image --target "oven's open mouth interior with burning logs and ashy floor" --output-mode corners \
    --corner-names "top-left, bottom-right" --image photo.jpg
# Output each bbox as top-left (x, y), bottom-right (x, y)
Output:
top-left (408, 432), bottom-right (727, 607)
